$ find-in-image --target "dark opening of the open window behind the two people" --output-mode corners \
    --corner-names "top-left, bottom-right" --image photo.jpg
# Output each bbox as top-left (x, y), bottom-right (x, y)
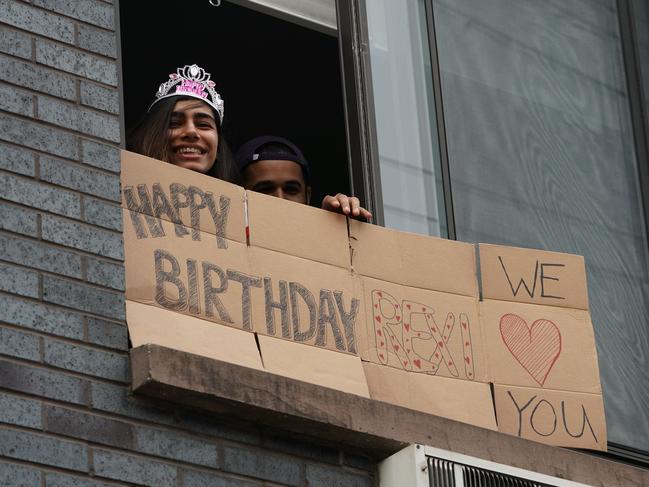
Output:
top-left (120, 0), bottom-right (351, 205)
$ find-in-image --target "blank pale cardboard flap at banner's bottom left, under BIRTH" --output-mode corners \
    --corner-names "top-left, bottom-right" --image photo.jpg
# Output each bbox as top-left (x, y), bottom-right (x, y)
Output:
top-left (126, 299), bottom-right (264, 370)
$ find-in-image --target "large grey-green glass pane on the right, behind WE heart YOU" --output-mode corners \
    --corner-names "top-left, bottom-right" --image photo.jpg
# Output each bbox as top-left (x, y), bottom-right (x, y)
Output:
top-left (434, 0), bottom-right (649, 450)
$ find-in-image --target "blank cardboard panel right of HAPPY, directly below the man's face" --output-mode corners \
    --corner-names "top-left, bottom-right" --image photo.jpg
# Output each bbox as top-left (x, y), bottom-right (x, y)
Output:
top-left (246, 191), bottom-right (350, 269)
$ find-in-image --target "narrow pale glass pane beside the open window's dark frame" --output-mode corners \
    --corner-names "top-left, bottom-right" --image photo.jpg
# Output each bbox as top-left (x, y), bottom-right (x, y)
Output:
top-left (367, 0), bottom-right (447, 236)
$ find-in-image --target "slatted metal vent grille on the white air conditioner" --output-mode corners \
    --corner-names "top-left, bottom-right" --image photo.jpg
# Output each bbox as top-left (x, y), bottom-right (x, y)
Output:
top-left (427, 456), bottom-right (556, 487)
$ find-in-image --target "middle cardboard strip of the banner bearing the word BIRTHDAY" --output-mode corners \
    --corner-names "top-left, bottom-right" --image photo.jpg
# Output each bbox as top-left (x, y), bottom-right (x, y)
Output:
top-left (124, 210), bottom-right (365, 355)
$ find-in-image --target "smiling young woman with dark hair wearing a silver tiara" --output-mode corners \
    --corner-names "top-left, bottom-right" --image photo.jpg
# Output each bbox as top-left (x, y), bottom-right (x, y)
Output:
top-left (126, 64), bottom-right (239, 183)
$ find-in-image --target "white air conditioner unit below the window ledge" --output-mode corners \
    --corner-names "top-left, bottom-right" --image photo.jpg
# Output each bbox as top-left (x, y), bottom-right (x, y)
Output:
top-left (379, 445), bottom-right (592, 487)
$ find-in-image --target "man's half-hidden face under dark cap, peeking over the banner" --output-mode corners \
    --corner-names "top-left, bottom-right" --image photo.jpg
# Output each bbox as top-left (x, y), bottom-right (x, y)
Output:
top-left (243, 160), bottom-right (311, 204)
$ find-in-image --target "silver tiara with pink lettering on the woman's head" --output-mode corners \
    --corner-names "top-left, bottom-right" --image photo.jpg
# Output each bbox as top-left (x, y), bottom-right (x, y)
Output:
top-left (149, 64), bottom-right (223, 123)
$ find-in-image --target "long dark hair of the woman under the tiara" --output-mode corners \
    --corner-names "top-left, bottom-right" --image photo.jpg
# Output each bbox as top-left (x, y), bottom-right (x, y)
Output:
top-left (126, 96), bottom-right (241, 184)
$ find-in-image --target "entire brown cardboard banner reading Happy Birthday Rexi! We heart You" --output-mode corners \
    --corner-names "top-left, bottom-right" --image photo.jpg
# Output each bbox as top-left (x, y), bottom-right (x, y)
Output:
top-left (121, 152), bottom-right (606, 450)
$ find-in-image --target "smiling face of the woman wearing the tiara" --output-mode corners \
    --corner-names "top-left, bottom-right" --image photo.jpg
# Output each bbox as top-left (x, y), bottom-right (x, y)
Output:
top-left (168, 100), bottom-right (219, 173)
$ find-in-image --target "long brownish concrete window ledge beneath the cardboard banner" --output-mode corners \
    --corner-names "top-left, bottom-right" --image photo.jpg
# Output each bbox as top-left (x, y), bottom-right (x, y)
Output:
top-left (131, 345), bottom-right (649, 487)
